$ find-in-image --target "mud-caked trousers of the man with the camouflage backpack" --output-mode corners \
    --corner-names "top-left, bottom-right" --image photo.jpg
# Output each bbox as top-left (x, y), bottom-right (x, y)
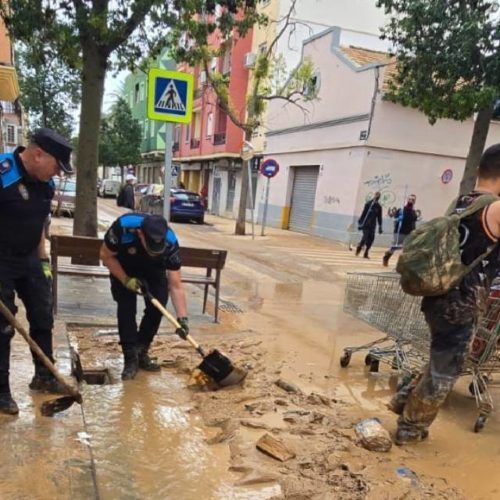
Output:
top-left (396, 302), bottom-right (474, 432)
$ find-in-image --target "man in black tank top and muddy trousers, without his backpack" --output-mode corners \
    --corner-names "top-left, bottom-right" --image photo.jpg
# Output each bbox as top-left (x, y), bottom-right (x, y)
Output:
top-left (389, 144), bottom-right (500, 444)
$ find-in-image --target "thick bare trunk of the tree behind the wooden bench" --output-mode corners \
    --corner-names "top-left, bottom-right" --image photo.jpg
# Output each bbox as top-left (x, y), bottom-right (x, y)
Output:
top-left (73, 44), bottom-right (106, 237)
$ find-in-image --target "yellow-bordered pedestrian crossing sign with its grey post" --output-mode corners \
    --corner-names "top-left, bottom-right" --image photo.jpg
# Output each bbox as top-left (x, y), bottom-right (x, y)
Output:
top-left (148, 68), bottom-right (193, 221)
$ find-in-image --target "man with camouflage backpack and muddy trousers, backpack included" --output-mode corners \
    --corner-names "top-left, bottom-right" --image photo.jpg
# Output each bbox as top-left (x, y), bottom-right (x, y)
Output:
top-left (389, 144), bottom-right (500, 444)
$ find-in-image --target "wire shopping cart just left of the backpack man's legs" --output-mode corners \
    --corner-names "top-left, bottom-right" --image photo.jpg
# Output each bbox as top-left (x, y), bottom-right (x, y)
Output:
top-left (340, 272), bottom-right (429, 375)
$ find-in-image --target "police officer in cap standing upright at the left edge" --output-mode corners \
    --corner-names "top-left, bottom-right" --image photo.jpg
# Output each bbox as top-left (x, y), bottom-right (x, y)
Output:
top-left (0, 128), bottom-right (73, 415)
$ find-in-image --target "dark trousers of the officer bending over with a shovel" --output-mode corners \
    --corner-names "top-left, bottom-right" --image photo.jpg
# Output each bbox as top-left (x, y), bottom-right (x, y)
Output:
top-left (111, 272), bottom-right (168, 350)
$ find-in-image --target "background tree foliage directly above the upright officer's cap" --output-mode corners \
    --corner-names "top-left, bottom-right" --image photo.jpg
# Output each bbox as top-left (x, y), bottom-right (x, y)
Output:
top-left (16, 41), bottom-right (81, 137)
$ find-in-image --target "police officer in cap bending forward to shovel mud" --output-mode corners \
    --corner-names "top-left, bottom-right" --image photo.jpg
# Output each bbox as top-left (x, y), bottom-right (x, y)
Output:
top-left (101, 213), bottom-right (189, 380)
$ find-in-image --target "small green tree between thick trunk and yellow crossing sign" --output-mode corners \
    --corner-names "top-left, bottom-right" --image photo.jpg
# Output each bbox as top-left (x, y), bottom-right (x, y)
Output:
top-left (99, 98), bottom-right (141, 167)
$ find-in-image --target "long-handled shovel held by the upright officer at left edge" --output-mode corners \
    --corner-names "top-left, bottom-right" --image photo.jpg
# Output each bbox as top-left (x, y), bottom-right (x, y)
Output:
top-left (0, 300), bottom-right (82, 417)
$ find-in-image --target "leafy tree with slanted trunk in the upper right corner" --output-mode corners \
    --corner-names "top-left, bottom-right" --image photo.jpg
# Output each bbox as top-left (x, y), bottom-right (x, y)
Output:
top-left (377, 0), bottom-right (500, 194)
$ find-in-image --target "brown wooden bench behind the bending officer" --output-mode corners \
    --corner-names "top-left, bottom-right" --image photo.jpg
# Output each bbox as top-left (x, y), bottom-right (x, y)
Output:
top-left (50, 235), bottom-right (227, 323)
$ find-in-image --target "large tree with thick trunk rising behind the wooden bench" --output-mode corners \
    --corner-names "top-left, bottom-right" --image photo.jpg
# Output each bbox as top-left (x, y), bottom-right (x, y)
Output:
top-left (0, 0), bottom-right (262, 236)
